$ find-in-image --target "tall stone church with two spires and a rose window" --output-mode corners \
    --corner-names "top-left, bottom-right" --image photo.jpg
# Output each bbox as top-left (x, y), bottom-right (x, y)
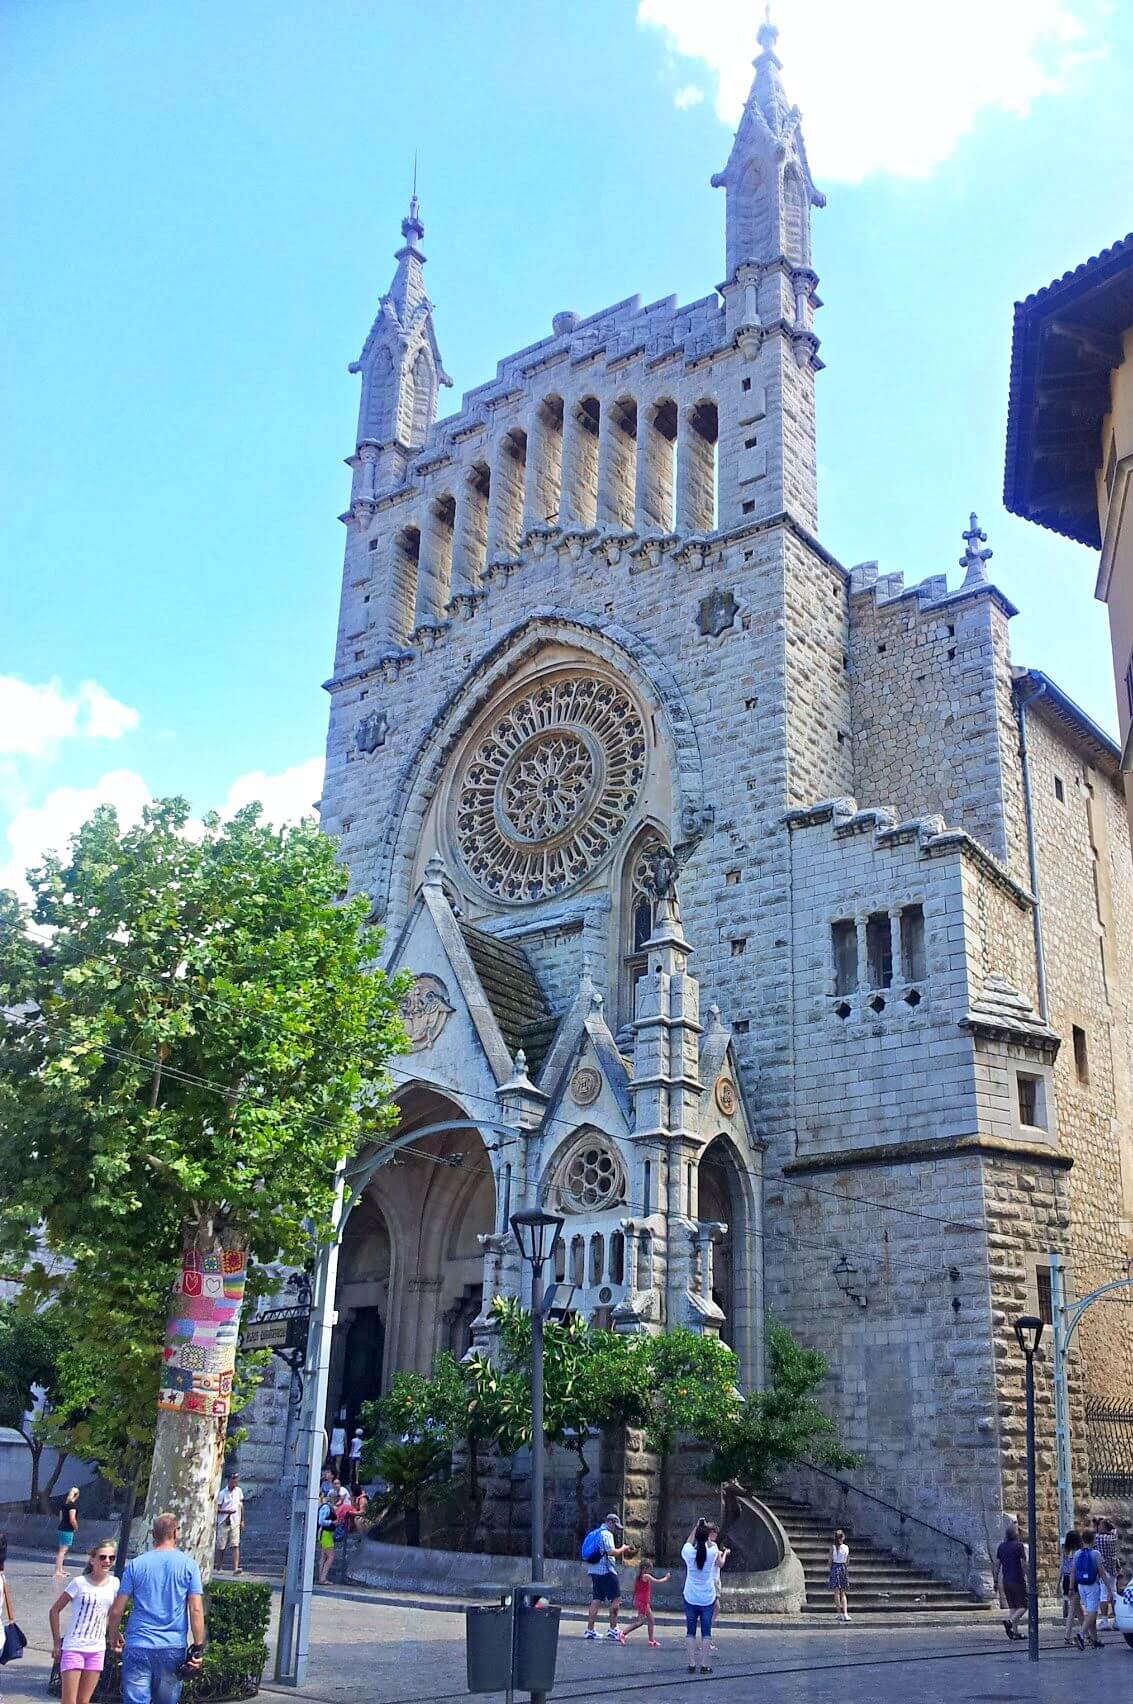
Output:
top-left (245, 24), bottom-right (1133, 1569)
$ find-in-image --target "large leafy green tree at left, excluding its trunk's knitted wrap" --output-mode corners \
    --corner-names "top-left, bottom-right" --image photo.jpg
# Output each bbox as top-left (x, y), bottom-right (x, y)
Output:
top-left (0, 799), bottom-right (404, 1566)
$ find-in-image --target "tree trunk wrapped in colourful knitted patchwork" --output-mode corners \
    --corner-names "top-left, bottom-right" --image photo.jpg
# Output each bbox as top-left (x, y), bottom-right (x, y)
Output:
top-left (145, 1217), bottom-right (247, 1580)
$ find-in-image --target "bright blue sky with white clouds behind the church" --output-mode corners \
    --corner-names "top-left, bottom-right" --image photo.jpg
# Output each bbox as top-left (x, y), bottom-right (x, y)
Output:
top-left (0, 0), bottom-right (1133, 899)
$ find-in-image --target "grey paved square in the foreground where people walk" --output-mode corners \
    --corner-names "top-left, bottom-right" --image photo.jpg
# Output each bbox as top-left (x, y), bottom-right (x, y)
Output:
top-left (0, 1556), bottom-right (1133, 1704)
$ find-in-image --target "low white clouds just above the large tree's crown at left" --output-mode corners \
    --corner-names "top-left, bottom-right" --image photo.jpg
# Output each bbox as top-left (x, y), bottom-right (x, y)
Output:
top-left (0, 753), bottom-right (324, 900)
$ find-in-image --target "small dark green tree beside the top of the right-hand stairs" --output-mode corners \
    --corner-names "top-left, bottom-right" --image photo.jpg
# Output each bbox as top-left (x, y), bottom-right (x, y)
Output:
top-left (705, 1319), bottom-right (859, 1491)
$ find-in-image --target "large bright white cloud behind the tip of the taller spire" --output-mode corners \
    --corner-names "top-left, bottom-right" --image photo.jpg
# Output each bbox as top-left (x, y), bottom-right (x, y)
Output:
top-left (637, 0), bottom-right (1087, 187)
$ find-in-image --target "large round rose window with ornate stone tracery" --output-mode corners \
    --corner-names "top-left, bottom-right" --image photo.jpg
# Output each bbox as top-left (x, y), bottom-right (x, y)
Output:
top-left (455, 675), bottom-right (646, 905)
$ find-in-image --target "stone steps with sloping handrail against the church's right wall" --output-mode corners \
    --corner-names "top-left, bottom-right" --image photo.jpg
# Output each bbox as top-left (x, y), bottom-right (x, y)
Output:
top-left (760, 1493), bottom-right (988, 1615)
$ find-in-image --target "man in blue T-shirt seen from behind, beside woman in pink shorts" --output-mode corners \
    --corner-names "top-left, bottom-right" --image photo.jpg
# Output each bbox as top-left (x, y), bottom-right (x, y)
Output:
top-left (107, 1515), bottom-right (204, 1704)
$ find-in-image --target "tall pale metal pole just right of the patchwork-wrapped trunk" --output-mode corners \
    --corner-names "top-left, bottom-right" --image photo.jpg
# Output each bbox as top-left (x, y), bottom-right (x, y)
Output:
top-left (276, 1166), bottom-right (346, 1687)
